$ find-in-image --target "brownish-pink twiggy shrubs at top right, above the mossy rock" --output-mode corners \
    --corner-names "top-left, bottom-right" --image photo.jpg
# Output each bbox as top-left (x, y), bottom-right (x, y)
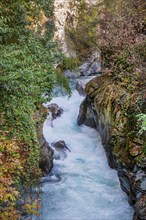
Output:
top-left (98, 0), bottom-right (145, 76)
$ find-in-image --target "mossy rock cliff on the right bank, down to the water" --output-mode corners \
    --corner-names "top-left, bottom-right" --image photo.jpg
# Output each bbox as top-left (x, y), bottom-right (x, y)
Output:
top-left (78, 76), bottom-right (146, 220)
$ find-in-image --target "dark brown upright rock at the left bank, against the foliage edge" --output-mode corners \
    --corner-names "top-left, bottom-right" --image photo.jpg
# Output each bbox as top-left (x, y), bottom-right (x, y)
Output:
top-left (39, 140), bottom-right (54, 176)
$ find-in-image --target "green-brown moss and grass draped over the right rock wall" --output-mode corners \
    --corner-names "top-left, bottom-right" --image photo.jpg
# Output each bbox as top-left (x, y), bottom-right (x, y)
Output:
top-left (86, 75), bottom-right (145, 164)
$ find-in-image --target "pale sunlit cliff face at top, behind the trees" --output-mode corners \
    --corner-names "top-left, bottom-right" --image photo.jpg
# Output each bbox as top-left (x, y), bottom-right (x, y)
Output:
top-left (54, 0), bottom-right (100, 57)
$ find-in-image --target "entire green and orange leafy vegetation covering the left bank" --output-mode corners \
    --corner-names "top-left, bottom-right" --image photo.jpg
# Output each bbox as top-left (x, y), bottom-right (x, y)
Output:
top-left (0, 0), bottom-right (67, 220)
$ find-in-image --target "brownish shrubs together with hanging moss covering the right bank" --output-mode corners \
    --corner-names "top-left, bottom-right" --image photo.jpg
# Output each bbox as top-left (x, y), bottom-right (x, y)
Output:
top-left (87, 0), bottom-right (146, 165)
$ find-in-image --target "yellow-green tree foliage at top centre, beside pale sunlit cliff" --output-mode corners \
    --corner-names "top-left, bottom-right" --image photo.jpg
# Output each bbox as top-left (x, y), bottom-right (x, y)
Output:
top-left (66, 0), bottom-right (99, 60)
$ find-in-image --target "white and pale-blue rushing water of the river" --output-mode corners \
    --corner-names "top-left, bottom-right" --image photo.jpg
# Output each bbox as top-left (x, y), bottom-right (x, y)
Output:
top-left (35, 88), bottom-right (133, 220)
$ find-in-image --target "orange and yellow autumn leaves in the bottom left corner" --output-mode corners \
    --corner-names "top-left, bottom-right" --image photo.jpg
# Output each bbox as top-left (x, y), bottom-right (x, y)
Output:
top-left (0, 131), bottom-right (26, 219)
